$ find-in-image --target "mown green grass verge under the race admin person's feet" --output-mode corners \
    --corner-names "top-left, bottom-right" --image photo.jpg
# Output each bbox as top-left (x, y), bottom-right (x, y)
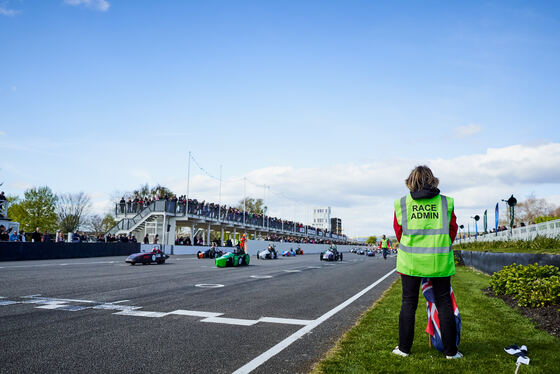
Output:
top-left (313, 267), bottom-right (560, 374)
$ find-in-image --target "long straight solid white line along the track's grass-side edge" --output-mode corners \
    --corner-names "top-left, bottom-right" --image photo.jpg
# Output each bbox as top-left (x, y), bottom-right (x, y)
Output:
top-left (233, 269), bottom-right (397, 374)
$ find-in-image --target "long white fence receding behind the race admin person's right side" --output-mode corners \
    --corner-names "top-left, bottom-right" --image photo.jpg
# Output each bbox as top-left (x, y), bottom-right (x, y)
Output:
top-left (455, 219), bottom-right (560, 244)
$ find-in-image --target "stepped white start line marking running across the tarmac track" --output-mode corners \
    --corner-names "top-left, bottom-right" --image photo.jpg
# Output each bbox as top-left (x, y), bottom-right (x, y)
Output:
top-left (0, 296), bottom-right (313, 326)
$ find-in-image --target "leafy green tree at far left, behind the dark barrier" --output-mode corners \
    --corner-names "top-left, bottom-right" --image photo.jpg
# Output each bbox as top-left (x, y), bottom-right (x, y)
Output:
top-left (8, 186), bottom-right (57, 231)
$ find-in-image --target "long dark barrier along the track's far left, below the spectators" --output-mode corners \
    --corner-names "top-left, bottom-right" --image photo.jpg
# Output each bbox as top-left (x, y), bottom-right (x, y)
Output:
top-left (0, 242), bottom-right (140, 261)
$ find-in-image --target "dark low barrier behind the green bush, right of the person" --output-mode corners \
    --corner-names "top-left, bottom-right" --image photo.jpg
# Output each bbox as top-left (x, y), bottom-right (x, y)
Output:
top-left (454, 251), bottom-right (560, 275)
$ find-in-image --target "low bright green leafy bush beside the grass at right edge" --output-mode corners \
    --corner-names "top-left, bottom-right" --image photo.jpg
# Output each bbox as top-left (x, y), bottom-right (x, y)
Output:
top-left (490, 263), bottom-right (560, 307)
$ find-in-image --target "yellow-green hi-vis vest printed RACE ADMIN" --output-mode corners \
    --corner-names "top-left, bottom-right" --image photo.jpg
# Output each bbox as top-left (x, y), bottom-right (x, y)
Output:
top-left (395, 194), bottom-right (455, 277)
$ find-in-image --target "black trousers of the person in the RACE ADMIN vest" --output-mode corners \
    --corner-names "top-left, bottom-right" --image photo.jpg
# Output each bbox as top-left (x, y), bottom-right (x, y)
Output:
top-left (399, 274), bottom-right (457, 356)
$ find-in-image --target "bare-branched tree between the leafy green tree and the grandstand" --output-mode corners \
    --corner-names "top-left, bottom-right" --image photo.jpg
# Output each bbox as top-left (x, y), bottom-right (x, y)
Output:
top-left (56, 192), bottom-right (91, 232)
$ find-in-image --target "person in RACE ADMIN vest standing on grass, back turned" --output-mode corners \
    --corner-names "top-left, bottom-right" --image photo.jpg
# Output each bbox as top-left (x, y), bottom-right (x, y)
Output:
top-left (393, 166), bottom-right (463, 359)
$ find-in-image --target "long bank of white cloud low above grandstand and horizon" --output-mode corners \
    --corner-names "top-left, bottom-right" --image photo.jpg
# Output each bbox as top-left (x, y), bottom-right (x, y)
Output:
top-left (82, 143), bottom-right (560, 236)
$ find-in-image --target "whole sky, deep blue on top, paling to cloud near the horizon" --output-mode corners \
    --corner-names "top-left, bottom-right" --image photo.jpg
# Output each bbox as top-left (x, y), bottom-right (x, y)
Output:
top-left (0, 0), bottom-right (560, 235)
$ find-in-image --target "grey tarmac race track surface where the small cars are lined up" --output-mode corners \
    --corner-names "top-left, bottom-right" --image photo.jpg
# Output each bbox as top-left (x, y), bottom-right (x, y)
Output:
top-left (0, 253), bottom-right (398, 373)
